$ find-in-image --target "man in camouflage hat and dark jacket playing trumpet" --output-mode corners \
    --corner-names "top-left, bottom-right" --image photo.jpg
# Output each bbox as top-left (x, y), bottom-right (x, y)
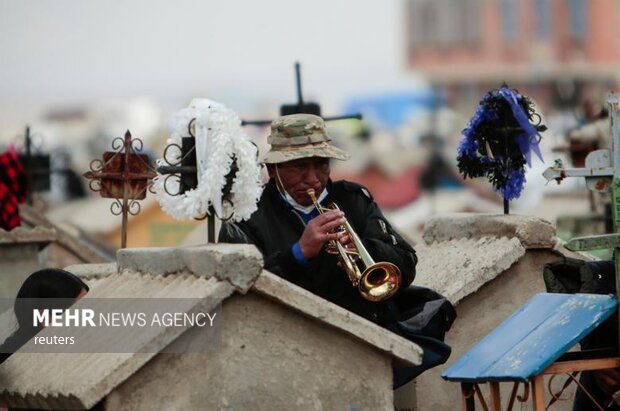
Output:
top-left (219, 114), bottom-right (451, 386)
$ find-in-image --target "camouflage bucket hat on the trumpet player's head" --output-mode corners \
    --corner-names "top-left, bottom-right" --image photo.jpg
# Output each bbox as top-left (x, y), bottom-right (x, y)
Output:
top-left (263, 114), bottom-right (349, 164)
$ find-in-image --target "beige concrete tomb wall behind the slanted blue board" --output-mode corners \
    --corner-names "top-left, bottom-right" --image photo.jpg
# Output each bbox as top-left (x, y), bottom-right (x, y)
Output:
top-left (416, 249), bottom-right (574, 411)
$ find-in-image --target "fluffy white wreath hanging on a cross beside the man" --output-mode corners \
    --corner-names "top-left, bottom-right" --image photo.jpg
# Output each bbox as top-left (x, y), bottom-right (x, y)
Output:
top-left (153, 99), bottom-right (262, 221)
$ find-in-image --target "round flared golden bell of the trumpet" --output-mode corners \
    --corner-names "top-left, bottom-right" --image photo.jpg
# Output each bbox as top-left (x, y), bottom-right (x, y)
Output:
top-left (358, 261), bottom-right (401, 302)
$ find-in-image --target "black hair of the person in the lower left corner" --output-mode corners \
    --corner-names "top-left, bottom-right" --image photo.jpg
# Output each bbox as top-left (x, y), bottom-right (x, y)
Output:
top-left (0, 268), bottom-right (89, 363)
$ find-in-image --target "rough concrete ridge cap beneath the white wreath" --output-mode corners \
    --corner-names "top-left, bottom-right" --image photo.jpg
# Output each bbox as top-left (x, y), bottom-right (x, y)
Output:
top-left (116, 244), bottom-right (263, 293)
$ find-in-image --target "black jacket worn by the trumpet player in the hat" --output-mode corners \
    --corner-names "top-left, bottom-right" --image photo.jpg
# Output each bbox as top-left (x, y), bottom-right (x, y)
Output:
top-left (219, 179), bottom-right (417, 324)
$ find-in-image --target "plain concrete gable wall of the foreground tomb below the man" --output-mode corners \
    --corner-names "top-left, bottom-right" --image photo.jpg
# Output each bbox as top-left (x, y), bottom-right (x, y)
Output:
top-left (102, 293), bottom-right (394, 411)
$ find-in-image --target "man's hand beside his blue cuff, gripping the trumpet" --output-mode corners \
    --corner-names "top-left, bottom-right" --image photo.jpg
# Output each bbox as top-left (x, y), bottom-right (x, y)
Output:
top-left (299, 210), bottom-right (344, 259)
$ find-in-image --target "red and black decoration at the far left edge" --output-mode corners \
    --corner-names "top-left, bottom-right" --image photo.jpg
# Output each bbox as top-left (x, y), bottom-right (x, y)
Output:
top-left (0, 150), bottom-right (28, 231)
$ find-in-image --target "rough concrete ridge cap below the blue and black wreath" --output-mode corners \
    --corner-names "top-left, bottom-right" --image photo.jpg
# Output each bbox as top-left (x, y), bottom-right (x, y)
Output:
top-left (423, 213), bottom-right (557, 248)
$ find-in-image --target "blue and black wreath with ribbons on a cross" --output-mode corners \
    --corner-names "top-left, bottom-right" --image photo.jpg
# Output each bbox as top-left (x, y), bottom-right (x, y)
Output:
top-left (457, 85), bottom-right (547, 200)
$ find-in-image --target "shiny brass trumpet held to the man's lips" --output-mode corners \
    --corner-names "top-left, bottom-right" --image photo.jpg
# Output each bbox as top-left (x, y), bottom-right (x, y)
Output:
top-left (306, 189), bottom-right (401, 302)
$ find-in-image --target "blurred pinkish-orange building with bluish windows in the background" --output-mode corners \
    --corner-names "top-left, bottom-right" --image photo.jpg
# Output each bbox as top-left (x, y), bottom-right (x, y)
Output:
top-left (407, 0), bottom-right (620, 109)
